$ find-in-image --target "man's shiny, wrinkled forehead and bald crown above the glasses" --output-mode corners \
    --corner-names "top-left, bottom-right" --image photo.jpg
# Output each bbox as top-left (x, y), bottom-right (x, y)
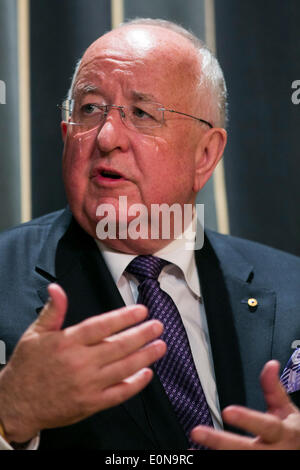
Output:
top-left (74, 26), bottom-right (200, 109)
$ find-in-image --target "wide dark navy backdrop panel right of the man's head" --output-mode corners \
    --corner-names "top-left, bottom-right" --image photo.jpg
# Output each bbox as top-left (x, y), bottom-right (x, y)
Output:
top-left (215, 0), bottom-right (300, 255)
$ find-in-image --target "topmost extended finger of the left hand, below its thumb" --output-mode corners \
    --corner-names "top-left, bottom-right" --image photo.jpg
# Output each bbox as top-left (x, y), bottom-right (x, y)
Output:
top-left (65, 305), bottom-right (148, 346)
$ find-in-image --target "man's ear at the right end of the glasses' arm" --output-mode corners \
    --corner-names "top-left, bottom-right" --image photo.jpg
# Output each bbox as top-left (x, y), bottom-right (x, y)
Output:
top-left (193, 127), bottom-right (227, 193)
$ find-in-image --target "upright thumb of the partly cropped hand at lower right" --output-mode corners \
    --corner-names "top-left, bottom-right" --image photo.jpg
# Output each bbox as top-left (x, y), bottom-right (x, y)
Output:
top-left (260, 360), bottom-right (294, 419)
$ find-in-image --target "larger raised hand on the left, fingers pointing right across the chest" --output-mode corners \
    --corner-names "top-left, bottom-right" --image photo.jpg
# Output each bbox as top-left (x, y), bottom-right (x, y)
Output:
top-left (0, 284), bottom-right (166, 442)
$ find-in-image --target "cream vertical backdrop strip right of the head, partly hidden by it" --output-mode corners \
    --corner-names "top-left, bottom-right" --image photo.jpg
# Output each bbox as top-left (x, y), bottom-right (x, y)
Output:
top-left (204, 0), bottom-right (229, 234)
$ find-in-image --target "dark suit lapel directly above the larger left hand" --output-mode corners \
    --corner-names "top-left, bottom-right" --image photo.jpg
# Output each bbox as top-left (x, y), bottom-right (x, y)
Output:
top-left (36, 210), bottom-right (124, 327)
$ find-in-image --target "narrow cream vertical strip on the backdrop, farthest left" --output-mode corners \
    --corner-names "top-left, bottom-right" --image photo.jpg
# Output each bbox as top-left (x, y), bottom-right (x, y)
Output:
top-left (18, 0), bottom-right (31, 222)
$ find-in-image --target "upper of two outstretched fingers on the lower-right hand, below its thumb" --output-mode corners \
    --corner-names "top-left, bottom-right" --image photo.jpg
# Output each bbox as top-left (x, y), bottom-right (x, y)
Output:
top-left (222, 406), bottom-right (283, 443)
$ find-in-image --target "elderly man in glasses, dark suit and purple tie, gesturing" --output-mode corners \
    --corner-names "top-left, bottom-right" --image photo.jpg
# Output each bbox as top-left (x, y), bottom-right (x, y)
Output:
top-left (0, 20), bottom-right (300, 450)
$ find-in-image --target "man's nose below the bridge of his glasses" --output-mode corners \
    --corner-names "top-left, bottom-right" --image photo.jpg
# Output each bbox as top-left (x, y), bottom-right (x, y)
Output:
top-left (97, 107), bottom-right (129, 153)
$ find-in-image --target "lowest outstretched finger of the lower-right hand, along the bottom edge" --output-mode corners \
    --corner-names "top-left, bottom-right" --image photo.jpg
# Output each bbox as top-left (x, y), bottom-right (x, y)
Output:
top-left (191, 426), bottom-right (263, 450)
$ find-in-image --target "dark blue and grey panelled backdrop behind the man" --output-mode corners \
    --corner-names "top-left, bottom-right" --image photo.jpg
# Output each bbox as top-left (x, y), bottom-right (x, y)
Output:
top-left (0, 0), bottom-right (300, 255)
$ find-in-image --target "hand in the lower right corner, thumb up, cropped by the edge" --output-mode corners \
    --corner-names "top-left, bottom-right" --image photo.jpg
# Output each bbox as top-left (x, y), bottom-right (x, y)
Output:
top-left (191, 360), bottom-right (300, 450)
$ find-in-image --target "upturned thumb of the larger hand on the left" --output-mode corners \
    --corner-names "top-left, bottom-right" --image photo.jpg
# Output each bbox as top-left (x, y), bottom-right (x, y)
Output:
top-left (33, 284), bottom-right (68, 332)
